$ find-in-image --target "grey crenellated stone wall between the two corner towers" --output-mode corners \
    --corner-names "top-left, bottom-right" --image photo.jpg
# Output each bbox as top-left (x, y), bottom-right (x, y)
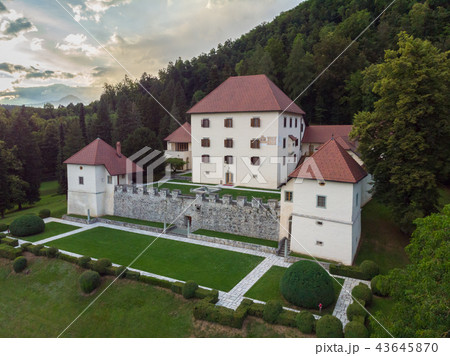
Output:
top-left (114, 186), bottom-right (280, 241)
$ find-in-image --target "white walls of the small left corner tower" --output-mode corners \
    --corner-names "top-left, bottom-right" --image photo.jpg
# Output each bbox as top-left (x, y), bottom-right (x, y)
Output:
top-left (67, 164), bottom-right (129, 217)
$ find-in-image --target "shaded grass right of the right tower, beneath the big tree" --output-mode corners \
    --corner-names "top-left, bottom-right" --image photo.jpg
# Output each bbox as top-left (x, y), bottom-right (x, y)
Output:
top-left (355, 199), bottom-right (409, 274)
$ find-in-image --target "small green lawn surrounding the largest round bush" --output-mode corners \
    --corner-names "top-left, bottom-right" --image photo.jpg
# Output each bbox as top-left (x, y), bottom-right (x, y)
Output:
top-left (245, 266), bottom-right (344, 314)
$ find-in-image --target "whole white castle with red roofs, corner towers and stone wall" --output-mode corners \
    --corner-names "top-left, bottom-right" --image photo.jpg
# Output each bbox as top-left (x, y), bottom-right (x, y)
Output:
top-left (65, 75), bottom-right (371, 264)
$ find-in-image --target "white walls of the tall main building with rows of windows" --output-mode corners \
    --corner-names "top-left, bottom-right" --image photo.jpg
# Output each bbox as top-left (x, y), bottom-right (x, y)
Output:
top-left (191, 112), bottom-right (305, 189)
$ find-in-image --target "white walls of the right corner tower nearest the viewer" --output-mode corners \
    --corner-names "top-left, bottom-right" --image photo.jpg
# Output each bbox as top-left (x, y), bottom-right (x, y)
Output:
top-left (280, 177), bottom-right (369, 265)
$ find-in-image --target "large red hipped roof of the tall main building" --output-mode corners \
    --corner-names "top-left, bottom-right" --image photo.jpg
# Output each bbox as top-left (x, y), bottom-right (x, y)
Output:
top-left (187, 74), bottom-right (305, 115)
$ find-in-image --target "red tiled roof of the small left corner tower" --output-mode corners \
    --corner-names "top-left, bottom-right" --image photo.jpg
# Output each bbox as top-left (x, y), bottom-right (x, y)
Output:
top-left (64, 138), bottom-right (143, 176)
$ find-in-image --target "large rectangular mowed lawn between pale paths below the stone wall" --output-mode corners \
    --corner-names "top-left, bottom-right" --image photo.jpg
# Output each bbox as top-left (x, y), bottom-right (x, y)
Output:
top-left (48, 227), bottom-right (263, 291)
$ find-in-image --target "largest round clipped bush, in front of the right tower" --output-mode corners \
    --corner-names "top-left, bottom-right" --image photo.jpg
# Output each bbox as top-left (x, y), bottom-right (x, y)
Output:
top-left (280, 261), bottom-right (335, 309)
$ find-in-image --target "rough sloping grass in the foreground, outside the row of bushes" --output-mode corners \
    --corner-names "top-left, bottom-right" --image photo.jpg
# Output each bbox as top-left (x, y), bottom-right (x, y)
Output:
top-left (0, 255), bottom-right (302, 337)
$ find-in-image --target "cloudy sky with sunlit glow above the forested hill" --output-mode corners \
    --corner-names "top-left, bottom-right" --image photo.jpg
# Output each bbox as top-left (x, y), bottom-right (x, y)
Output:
top-left (0, 0), bottom-right (299, 105)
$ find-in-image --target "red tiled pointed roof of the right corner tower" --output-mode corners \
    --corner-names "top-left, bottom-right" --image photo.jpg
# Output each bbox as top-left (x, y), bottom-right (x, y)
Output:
top-left (289, 139), bottom-right (367, 183)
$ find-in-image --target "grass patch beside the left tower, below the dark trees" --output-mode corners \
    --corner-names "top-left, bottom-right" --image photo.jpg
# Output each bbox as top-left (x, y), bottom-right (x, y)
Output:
top-left (0, 181), bottom-right (67, 224)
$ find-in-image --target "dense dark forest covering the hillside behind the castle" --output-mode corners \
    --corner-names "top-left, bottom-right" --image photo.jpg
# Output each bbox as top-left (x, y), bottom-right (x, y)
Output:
top-left (0, 0), bottom-right (450, 214)
